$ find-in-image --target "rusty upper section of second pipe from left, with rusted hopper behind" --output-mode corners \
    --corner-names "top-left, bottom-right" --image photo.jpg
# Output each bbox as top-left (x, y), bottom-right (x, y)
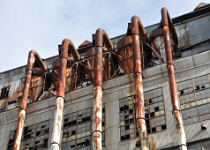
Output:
top-left (51, 39), bottom-right (81, 92)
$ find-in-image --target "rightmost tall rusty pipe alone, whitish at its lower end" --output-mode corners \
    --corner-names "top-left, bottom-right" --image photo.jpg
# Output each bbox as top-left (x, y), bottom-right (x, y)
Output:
top-left (161, 8), bottom-right (187, 150)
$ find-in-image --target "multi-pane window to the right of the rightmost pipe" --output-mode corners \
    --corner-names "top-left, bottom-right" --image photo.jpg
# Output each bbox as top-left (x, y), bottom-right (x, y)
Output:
top-left (177, 75), bottom-right (210, 125)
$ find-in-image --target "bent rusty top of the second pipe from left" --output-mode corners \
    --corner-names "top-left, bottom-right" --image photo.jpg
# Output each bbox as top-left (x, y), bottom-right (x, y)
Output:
top-left (60, 38), bottom-right (81, 60)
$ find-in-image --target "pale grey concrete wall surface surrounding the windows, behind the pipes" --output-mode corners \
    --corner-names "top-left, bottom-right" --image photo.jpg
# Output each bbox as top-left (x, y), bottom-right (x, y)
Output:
top-left (0, 51), bottom-right (210, 150)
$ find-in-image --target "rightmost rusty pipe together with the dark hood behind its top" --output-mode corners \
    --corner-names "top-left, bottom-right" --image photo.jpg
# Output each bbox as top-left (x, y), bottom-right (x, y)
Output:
top-left (150, 8), bottom-right (187, 150)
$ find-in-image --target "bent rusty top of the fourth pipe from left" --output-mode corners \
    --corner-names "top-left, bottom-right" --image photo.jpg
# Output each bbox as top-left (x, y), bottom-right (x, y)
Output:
top-left (131, 16), bottom-right (147, 37)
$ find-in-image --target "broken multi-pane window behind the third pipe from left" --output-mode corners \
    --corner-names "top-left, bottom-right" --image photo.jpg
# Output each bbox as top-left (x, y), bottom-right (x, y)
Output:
top-left (62, 105), bottom-right (105, 150)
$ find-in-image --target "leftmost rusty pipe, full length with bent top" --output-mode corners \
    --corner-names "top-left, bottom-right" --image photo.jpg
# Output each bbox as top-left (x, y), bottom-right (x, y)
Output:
top-left (13, 50), bottom-right (48, 150)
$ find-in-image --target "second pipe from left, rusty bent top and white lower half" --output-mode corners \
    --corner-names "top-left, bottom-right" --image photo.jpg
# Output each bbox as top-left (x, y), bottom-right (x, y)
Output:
top-left (50, 39), bottom-right (80, 150)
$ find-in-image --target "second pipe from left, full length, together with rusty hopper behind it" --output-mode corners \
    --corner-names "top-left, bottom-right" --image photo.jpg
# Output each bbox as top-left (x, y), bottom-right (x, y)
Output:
top-left (51, 39), bottom-right (81, 149)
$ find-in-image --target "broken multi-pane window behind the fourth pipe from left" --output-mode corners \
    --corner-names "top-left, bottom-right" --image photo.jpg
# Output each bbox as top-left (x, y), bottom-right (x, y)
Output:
top-left (120, 88), bottom-right (166, 141)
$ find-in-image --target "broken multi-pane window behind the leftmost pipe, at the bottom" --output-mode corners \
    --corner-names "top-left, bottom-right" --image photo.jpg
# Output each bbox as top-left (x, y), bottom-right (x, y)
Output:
top-left (7, 121), bottom-right (50, 150)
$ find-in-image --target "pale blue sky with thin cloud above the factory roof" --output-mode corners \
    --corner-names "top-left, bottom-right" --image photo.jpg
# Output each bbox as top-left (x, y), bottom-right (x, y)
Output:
top-left (0, 0), bottom-right (207, 72)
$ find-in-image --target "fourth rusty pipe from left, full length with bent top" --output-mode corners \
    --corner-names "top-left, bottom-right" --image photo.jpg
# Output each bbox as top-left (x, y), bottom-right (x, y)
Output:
top-left (131, 16), bottom-right (149, 150)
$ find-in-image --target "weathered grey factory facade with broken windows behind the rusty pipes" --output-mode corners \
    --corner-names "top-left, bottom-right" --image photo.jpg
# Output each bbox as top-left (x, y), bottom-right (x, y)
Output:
top-left (0, 5), bottom-right (210, 150)
